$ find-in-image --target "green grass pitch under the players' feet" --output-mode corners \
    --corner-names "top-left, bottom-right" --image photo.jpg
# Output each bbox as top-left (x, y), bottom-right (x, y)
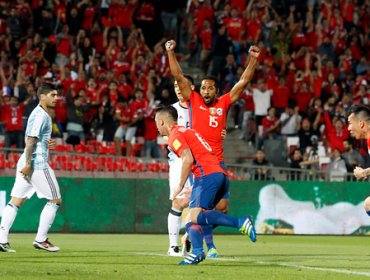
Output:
top-left (0, 234), bottom-right (370, 280)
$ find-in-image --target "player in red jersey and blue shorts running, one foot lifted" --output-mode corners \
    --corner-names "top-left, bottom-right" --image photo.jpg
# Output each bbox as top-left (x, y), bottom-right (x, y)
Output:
top-left (155, 106), bottom-right (256, 265)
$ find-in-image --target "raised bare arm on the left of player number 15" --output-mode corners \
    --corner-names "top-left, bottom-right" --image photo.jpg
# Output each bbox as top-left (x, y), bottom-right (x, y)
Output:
top-left (165, 40), bottom-right (192, 100)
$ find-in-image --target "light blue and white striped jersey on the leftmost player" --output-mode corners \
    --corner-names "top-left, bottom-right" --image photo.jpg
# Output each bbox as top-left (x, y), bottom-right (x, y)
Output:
top-left (17, 105), bottom-right (52, 169)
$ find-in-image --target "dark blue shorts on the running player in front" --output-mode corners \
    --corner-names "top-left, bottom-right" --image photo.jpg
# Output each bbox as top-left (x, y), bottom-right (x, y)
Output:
top-left (189, 172), bottom-right (229, 210)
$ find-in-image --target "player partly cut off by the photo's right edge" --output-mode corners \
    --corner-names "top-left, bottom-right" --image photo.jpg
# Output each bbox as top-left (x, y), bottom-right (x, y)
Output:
top-left (348, 105), bottom-right (370, 216)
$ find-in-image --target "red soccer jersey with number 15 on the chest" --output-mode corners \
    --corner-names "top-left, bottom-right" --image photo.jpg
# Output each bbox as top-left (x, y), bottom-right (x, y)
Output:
top-left (188, 91), bottom-right (231, 161)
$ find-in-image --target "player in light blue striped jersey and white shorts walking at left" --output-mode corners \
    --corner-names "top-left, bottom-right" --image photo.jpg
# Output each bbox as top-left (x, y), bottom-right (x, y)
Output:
top-left (0, 83), bottom-right (62, 253)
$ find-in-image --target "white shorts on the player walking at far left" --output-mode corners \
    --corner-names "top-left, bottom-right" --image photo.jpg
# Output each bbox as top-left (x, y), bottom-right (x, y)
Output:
top-left (11, 167), bottom-right (61, 200)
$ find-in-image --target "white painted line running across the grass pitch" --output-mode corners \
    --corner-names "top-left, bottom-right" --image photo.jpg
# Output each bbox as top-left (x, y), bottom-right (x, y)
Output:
top-left (134, 252), bottom-right (370, 277)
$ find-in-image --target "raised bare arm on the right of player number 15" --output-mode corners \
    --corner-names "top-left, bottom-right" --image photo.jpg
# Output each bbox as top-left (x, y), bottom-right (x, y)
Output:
top-left (230, 46), bottom-right (260, 103)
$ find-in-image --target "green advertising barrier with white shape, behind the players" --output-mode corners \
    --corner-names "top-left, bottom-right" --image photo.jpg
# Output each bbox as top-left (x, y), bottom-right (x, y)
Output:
top-left (0, 177), bottom-right (370, 235)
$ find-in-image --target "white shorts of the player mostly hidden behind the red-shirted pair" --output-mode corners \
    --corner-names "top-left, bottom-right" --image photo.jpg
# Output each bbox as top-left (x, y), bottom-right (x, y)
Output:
top-left (169, 157), bottom-right (193, 199)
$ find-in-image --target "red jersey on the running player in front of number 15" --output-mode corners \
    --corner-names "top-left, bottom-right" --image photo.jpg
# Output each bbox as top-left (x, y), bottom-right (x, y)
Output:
top-left (168, 125), bottom-right (225, 178)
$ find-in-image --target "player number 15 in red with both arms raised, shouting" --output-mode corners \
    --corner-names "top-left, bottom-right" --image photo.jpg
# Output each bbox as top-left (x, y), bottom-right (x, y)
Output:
top-left (165, 40), bottom-right (260, 257)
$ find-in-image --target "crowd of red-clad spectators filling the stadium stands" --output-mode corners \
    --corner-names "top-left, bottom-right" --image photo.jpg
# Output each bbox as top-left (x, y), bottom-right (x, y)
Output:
top-left (0, 0), bottom-right (370, 175)
